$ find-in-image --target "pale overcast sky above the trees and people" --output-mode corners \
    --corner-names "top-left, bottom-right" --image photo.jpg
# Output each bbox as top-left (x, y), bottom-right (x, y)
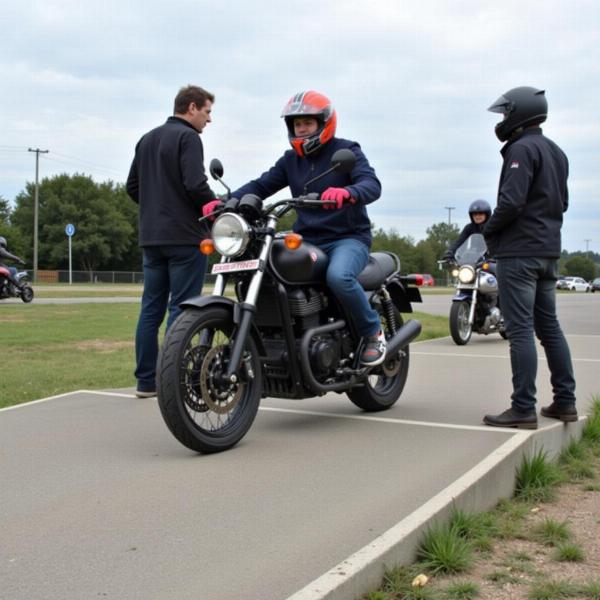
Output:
top-left (0, 0), bottom-right (600, 252)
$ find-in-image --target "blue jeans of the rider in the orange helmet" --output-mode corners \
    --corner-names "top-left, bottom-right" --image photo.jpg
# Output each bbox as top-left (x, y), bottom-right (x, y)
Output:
top-left (319, 238), bottom-right (381, 336)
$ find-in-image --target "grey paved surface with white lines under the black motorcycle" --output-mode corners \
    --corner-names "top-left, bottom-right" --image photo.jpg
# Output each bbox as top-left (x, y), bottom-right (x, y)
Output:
top-left (0, 294), bottom-right (600, 600)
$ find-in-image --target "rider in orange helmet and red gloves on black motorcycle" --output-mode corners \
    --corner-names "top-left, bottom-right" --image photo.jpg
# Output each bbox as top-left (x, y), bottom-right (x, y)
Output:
top-left (219, 91), bottom-right (386, 366)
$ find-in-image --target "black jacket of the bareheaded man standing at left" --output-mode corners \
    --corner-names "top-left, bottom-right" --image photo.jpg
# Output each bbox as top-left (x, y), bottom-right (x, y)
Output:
top-left (126, 117), bottom-right (215, 246)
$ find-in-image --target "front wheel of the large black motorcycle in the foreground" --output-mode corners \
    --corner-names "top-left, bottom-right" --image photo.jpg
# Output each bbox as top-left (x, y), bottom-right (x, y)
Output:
top-left (157, 307), bottom-right (262, 454)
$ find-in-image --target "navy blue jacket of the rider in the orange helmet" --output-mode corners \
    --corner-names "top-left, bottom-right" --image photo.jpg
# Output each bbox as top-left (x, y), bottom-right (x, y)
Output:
top-left (232, 138), bottom-right (381, 247)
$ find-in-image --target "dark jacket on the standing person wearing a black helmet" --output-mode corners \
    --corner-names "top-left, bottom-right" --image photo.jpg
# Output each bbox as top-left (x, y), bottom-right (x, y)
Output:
top-left (483, 127), bottom-right (569, 258)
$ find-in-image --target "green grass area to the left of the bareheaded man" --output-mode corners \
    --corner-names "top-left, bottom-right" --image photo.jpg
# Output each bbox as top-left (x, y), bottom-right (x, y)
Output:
top-left (0, 303), bottom-right (145, 408)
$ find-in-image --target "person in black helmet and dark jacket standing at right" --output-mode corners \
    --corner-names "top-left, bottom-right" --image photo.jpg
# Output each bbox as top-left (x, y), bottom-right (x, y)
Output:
top-left (483, 87), bottom-right (577, 429)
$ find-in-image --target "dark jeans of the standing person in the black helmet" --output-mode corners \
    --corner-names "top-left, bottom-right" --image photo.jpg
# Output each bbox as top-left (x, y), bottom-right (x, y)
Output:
top-left (496, 257), bottom-right (575, 411)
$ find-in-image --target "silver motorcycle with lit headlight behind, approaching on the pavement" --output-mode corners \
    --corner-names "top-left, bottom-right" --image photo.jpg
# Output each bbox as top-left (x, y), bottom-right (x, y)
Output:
top-left (439, 233), bottom-right (506, 346)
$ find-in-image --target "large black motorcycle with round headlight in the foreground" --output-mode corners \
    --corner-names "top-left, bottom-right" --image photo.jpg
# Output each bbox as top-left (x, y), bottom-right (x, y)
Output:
top-left (157, 150), bottom-right (421, 453)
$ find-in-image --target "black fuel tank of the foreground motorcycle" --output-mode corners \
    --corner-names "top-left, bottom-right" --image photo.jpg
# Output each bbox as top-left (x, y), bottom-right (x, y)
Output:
top-left (269, 239), bottom-right (329, 284)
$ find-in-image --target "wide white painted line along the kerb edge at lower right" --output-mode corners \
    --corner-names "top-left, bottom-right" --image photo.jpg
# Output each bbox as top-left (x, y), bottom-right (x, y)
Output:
top-left (286, 431), bottom-right (535, 600)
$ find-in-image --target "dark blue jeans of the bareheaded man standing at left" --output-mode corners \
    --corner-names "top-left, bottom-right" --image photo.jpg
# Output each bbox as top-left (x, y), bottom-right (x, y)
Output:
top-left (135, 246), bottom-right (206, 392)
